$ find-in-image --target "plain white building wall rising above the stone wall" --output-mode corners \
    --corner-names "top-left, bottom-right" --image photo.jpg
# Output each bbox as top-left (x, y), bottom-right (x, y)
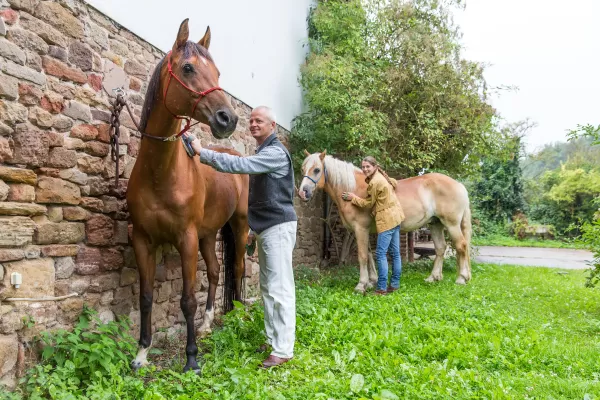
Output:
top-left (86, 0), bottom-right (312, 129)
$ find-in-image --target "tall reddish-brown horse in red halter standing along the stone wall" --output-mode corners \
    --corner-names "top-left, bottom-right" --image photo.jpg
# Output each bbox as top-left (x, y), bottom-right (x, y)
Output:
top-left (127, 19), bottom-right (248, 371)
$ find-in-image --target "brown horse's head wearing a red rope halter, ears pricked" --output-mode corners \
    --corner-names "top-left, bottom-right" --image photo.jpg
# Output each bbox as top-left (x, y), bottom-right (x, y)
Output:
top-left (161, 19), bottom-right (238, 139)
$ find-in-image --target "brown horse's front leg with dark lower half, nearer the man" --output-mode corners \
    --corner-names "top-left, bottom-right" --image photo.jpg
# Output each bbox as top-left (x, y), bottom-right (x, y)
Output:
top-left (177, 228), bottom-right (200, 372)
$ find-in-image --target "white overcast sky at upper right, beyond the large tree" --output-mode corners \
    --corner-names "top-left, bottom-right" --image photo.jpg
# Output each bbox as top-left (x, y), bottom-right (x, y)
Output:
top-left (455, 0), bottom-right (600, 151)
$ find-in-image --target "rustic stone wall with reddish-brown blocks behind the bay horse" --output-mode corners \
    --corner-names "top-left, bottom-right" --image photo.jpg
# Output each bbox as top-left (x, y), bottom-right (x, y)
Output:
top-left (0, 0), bottom-right (322, 385)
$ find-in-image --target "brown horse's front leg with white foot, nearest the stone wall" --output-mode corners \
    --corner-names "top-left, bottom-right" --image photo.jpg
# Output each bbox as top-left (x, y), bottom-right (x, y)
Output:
top-left (131, 228), bottom-right (156, 371)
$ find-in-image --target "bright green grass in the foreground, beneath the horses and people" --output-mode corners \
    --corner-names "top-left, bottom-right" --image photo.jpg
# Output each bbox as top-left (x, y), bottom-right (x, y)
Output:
top-left (8, 262), bottom-right (600, 400)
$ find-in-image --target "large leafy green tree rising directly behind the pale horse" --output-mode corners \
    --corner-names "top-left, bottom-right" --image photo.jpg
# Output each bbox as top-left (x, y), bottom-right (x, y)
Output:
top-left (292, 0), bottom-right (499, 176)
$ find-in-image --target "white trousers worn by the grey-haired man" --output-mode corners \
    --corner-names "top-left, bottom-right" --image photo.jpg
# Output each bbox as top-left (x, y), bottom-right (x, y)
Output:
top-left (257, 221), bottom-right (297, 358)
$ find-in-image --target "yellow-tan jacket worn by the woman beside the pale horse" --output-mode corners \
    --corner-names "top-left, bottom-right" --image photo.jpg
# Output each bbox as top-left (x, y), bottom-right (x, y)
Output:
top-left (352, 171), bottom-right (404, 233)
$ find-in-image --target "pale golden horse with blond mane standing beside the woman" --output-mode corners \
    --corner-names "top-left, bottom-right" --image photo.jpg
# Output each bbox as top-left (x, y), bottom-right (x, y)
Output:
top-left (300, 150), bottom-right (471, 292)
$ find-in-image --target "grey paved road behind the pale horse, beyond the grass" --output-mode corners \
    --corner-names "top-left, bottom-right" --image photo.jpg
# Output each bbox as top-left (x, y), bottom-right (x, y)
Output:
top-left (418, 243), bottom-right (594, 269)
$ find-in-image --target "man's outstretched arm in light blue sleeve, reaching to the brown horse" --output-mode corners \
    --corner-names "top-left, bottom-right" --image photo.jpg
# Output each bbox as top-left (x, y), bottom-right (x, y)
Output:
top-left (200, 146), bottom-right (288, 174)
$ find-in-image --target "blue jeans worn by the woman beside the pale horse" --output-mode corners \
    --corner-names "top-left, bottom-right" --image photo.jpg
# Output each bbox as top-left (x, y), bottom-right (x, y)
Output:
top-left (375, 225), bottom-right (402, 290)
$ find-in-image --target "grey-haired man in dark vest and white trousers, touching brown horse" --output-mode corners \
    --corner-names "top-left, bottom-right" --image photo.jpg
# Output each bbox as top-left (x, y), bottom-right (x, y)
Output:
top-left (186, 106), bottom-right (298, 368)
